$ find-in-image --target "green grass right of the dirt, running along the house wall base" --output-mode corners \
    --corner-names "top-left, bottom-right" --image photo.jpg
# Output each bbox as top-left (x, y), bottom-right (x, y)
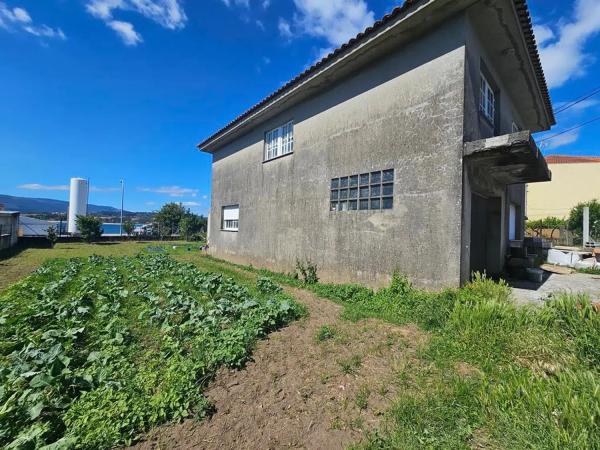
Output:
top-left (0, 248), bottom-right (600, 449)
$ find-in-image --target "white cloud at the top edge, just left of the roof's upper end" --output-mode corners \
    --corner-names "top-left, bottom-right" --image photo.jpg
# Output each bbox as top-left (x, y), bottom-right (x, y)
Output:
top-left (279, 0), bottom-right (375, 47)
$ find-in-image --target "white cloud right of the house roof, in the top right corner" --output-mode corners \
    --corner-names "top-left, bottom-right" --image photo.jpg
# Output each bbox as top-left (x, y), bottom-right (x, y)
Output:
top-left (535, 0), bottom-right (600, 88)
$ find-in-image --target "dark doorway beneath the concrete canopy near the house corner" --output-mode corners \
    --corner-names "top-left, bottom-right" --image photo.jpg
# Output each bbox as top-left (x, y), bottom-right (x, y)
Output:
top-left (470, 193), bottom-right (502, 276)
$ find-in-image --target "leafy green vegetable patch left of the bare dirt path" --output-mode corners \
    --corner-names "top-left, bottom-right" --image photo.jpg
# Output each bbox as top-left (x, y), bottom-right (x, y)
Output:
top-left (0, 254), bottom-right (302, 450)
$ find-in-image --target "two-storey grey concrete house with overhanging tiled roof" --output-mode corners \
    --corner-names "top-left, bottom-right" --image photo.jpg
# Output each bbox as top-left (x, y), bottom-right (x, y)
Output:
top-left (198, 0), bottom-right (555, 288)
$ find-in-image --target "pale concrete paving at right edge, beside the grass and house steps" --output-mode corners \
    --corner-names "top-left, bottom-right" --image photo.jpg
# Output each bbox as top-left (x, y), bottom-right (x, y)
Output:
top-left (509, 273), bottom-right (600, 304)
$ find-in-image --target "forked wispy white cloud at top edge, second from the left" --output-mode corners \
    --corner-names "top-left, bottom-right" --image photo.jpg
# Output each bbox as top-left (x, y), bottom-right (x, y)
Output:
top-left (86, 0), bottom-right (187, 46)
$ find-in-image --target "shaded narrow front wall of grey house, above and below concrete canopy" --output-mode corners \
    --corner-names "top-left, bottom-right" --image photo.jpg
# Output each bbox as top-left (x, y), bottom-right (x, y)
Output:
top-left (461, 4), bottom-right (525, 281)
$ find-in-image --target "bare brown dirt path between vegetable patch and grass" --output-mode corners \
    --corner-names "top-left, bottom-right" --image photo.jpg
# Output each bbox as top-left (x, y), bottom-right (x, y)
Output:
top-left (135, 280), bottom-right (426, 449)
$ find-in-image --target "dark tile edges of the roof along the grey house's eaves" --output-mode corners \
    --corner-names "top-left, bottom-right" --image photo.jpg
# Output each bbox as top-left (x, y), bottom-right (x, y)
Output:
top-left (198, 0), bottom-right (554, 148)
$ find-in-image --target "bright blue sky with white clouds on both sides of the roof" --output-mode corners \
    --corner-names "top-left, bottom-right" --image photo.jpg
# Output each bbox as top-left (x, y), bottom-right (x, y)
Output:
top-left (0, 0), bottom-right (600, 213)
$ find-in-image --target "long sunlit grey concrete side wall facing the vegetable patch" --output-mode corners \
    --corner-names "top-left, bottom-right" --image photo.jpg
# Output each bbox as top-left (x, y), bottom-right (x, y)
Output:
top-left (210, 16), bottom-right (465, 288)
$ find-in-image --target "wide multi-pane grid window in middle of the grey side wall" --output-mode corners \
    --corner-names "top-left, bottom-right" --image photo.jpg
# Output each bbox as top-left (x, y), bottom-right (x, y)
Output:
top-left (330, 169), bottom-right (394, 211)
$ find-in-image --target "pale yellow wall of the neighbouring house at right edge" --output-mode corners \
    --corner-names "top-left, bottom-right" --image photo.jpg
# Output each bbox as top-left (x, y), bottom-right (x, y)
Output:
top-left (527, 155), bottom-right (600, 220)
